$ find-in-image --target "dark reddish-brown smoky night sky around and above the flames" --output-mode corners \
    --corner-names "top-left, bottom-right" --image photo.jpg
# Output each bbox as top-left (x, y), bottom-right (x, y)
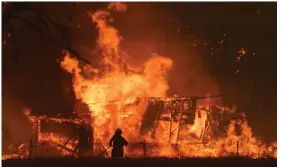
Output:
top-left (2, 2), bottom-right (277, 144)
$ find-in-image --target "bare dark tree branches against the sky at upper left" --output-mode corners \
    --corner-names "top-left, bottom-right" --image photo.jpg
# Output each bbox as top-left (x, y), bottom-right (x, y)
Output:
top-left (2, 2), bottom-right (91, 64)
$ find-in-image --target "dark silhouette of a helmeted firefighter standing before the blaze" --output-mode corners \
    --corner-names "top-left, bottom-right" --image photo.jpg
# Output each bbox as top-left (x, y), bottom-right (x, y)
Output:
top-left (109, 128), bottom-right (128, 158)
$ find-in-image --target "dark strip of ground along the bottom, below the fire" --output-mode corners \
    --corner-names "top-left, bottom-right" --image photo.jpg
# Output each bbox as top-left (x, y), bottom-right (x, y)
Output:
top-left (2, 158), bottom-right (277, 167)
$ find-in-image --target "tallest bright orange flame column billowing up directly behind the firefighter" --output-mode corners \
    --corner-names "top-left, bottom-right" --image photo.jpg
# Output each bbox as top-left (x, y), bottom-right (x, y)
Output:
top-left (61, 3), bottom-right (173, 149)
